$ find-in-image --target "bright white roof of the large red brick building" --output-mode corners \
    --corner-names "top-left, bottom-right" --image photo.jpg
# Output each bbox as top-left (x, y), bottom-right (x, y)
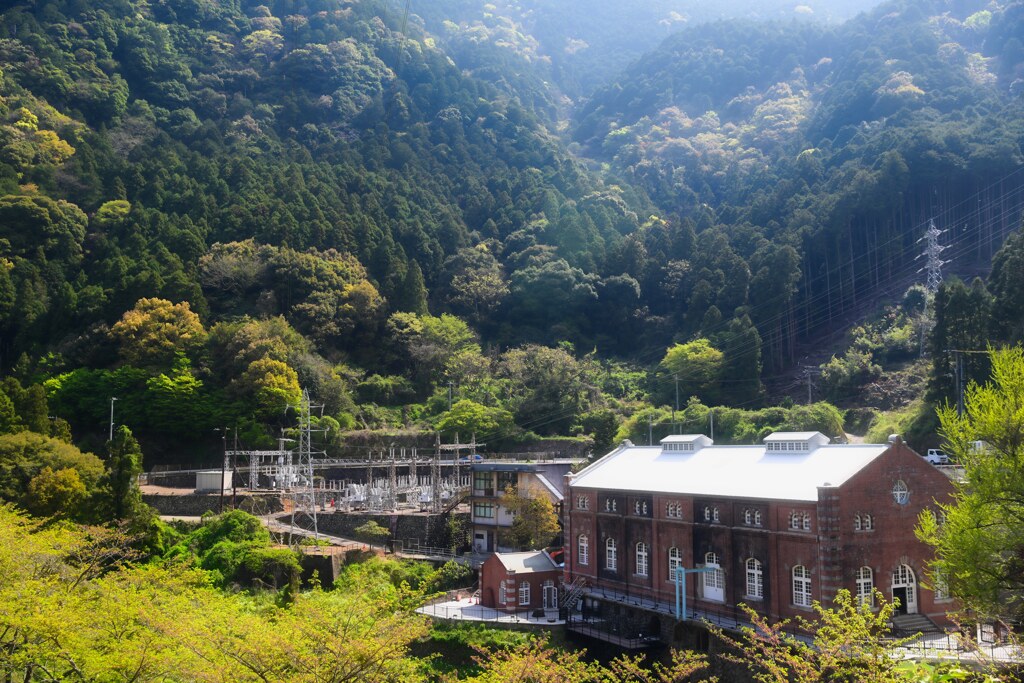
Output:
top-left (570, 432), bottom-right (889, 502)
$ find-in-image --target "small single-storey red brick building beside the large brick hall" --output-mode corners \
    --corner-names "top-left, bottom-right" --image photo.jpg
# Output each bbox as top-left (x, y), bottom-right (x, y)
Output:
top-left (480, 550), bottom-right (562, 611)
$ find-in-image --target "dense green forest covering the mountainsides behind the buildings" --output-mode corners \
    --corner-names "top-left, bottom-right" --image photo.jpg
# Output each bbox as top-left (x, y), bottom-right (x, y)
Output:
top-left (0, 0), bottom-right (1024, 460)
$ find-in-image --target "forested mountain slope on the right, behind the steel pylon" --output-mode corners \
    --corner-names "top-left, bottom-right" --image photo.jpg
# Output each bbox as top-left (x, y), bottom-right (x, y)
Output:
top-left (572, 1), bottom-right (1024, 368)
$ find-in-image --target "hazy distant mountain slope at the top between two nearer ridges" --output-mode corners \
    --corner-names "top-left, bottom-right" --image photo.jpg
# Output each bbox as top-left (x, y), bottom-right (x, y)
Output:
top-left (407, 0), bottom-right (878, 99)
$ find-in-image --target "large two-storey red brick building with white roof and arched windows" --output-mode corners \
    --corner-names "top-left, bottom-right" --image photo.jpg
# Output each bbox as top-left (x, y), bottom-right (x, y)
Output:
top-left (564, 432), bottom-right (952, 624)
